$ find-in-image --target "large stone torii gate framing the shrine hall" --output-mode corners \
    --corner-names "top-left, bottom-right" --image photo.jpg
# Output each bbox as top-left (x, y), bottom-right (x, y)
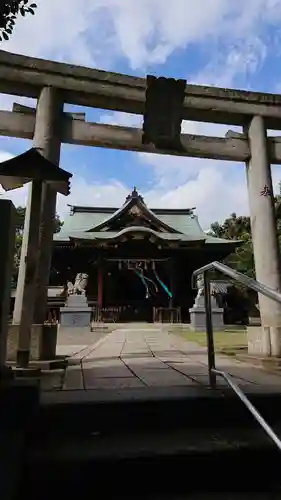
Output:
top-left (0, 51), bottom-right (281, 356)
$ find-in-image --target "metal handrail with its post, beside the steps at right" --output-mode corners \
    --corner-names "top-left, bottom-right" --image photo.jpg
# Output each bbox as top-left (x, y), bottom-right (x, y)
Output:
top-left (192, 261), bottom-right (281, 451)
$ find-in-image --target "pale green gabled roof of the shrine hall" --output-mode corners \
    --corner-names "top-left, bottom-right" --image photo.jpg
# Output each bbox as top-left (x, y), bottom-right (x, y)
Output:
top-left (54, 188), bottom-right (239, 251)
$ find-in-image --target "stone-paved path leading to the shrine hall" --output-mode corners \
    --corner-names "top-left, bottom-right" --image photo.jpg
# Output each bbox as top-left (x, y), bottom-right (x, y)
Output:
top-left (57, 325), bottom-right (281, 392)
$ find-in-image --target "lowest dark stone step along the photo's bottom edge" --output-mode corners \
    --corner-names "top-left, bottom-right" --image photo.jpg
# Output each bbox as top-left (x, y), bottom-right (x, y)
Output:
top-left (16, 429), bottom-right (281, 500)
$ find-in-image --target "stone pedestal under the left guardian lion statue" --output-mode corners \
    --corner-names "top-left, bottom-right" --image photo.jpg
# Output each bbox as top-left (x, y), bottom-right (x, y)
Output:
top-left (60, 294), bottom-right (92, 327)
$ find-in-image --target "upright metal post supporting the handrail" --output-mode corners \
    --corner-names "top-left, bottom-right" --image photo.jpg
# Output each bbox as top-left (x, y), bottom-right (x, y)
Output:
top-left (203, 271), bottom-right (217, 388)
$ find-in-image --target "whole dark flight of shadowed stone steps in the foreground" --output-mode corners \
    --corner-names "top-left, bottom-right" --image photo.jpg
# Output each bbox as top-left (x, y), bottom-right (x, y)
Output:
top-left (10, 389), bottom-right (281, 500)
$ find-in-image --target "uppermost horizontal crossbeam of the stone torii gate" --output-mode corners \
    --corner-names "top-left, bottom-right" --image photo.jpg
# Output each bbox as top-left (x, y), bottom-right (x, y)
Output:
top-left (0, 50), bottom-right (281, 129)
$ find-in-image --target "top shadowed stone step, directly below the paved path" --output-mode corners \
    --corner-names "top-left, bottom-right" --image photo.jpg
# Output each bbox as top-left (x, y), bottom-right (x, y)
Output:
top-left (34, 387), bottom-right (281, 434)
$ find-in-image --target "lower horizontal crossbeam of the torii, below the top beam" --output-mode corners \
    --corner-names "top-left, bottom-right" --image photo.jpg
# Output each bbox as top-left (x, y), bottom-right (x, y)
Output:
top-left (0, 111), bottom-right (281, 164)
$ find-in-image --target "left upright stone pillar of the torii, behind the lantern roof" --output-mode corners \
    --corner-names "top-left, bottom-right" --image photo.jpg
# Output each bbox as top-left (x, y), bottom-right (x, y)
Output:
top-left (13, 87), bottom-right (63, 324)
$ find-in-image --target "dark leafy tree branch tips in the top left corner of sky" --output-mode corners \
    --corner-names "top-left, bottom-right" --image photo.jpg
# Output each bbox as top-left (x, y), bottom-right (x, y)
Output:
top-left (0, 0), bottom-right (37, 41)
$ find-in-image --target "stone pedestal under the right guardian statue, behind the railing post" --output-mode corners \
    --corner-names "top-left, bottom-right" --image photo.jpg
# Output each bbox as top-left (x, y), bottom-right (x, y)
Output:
top-left (189, 296), bottom-right (224, 332)
